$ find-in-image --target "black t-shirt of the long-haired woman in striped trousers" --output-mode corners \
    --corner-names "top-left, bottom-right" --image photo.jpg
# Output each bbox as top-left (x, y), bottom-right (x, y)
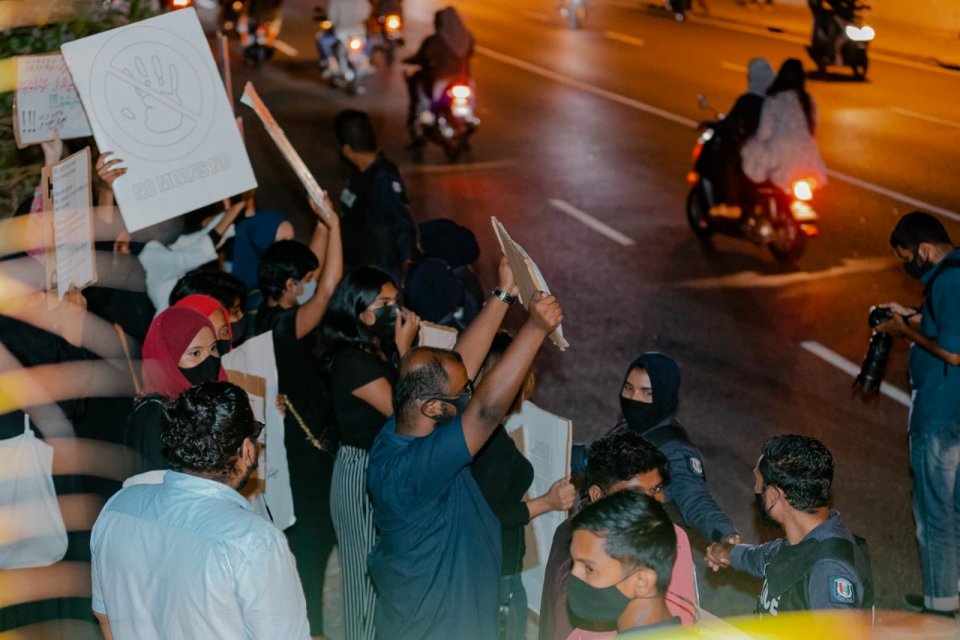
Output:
top-left (330, 347), bottom-right (397, 451)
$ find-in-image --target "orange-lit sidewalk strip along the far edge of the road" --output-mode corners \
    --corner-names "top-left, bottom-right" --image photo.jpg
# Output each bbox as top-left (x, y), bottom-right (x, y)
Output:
top-left (693, 0), bottom-right (960, 73)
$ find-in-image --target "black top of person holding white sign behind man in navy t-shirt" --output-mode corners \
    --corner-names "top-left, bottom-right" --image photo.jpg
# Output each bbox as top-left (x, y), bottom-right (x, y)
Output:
top-left (473, 425), bottom-right (533, 576)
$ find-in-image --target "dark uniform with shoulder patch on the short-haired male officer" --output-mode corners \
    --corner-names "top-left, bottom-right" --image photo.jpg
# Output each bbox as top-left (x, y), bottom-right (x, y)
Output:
top-left (730, 510), bottom-right (873, 616)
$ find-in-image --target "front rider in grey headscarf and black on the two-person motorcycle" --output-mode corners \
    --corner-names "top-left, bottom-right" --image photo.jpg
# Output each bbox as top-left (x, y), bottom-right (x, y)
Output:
top-left (695, 58), bottom-right (775, 218)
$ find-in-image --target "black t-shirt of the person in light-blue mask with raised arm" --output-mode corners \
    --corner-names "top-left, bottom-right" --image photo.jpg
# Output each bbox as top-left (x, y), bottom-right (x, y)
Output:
top-left (256, 302), bottom-right (330, 459)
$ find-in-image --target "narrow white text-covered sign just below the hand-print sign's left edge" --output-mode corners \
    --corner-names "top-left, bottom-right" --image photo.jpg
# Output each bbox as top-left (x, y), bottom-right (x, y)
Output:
top-left (47, 147), bottom-right (97, 300)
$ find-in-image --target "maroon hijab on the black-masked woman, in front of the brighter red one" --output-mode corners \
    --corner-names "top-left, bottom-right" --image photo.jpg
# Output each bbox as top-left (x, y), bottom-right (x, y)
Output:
top-left (141, 307), bottom-right (227, 400)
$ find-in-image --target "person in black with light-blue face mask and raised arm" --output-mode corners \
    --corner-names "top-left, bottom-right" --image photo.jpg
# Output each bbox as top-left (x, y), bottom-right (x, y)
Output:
top-left (256, 199), bottom-right (343, 636)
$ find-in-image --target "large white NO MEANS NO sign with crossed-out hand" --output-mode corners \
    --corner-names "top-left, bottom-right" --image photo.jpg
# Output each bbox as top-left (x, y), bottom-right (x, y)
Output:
top-left (60, 8), bottom-right (257, 232)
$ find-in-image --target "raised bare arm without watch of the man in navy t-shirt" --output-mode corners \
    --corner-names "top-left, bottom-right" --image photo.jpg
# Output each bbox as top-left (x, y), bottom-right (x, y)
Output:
top-left (457, 292), bottom-right (563, 455)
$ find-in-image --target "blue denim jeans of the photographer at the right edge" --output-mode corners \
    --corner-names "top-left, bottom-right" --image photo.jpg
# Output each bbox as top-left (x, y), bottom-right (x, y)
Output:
top-left (910, 423), bottom-right (960, 610)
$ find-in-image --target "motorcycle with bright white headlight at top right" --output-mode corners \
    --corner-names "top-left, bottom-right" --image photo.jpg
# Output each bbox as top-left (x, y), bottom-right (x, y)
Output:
top-left (807, 0), bottom-right (876, 80)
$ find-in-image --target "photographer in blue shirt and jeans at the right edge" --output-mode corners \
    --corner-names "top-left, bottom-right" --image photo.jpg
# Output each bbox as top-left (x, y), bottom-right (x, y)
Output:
top-left (875, 211), bottom-right (960, 617)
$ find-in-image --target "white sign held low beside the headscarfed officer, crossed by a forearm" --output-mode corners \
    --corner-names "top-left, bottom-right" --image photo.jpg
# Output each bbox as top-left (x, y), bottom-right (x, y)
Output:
top-left (504, 400), bottom-right (573, 613)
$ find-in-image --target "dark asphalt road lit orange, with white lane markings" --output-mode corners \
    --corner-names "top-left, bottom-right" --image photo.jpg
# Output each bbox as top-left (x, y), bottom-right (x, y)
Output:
top-left (218, 0), bottom-right (960, 615)
